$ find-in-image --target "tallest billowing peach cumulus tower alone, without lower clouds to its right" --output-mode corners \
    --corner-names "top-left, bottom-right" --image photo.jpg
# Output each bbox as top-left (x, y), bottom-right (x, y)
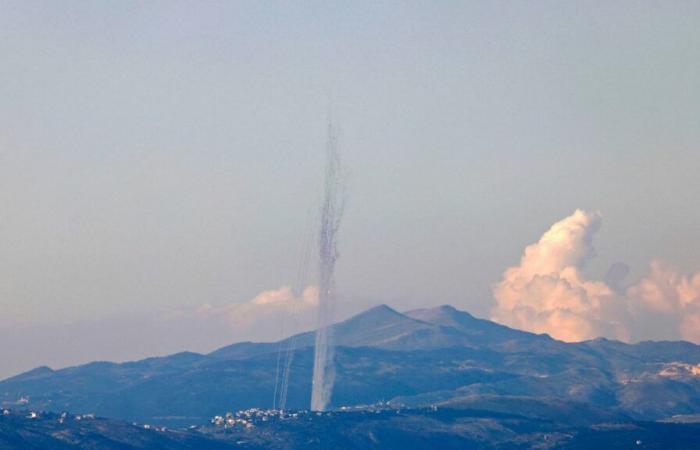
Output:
top-left (492, 210), bottom-right (628, 341)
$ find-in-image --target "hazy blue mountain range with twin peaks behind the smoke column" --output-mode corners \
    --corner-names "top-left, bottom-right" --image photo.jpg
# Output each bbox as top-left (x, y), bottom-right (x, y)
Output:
top-left (0, 306), bottom-right (700, 426)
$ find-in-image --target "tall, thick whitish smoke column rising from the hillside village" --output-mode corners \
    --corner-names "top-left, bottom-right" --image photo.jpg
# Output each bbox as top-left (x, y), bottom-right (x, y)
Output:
top-left (311, 120), bottom-right (343, 411)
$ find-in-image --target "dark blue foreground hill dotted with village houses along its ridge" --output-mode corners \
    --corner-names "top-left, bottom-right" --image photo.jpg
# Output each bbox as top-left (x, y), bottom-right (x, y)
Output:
top-left (0, 407), bottom-right (700, 450)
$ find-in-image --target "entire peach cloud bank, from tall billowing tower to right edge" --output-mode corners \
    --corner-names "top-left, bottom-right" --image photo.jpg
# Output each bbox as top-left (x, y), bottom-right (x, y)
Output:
top-left (492, 210), bottom-right (700, 342)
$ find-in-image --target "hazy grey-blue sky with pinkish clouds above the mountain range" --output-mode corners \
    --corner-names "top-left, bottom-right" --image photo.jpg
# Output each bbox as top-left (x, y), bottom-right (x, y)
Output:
top-left (0, 1), bottom-right (700, 377)
